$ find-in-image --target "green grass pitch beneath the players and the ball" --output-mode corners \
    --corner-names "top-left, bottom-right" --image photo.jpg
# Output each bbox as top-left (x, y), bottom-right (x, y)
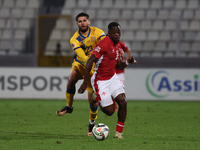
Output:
top-left (0, 100), bottom-right (200, 150)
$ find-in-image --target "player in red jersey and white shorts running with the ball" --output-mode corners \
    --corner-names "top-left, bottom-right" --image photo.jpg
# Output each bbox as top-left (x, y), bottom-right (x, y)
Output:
top-left (78, 22), bottom-right (137, 139)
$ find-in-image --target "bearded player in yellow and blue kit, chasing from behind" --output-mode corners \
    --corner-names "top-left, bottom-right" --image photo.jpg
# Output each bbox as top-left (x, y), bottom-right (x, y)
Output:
top-left (57, 13), bottom-right (106, 136)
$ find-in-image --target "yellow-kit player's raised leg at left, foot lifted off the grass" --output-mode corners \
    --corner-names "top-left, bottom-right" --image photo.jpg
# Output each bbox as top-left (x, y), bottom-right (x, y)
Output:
top-left (56, 67), bottom-right (82, 116)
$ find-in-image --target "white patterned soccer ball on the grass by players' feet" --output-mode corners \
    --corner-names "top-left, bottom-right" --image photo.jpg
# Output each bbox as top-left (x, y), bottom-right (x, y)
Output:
top-left (92, 123), bottom-right (110, 141)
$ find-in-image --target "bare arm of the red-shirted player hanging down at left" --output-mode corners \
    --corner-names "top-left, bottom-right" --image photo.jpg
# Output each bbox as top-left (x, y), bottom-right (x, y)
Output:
top-left (78, 54), bottom-right (98, 93)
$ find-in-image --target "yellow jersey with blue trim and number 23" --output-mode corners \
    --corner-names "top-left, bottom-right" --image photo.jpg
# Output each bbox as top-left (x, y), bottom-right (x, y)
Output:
top-left (70, 26), bottom-right (106, 66)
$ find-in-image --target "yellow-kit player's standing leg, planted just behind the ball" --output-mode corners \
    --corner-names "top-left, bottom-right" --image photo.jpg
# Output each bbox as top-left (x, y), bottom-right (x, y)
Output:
top-left (87, 92), bottom-right (98, 136)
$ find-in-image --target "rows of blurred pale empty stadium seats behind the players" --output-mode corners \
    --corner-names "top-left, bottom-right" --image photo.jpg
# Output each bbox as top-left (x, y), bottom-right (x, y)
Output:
top-left (0, 0), bottom-right (200, 67)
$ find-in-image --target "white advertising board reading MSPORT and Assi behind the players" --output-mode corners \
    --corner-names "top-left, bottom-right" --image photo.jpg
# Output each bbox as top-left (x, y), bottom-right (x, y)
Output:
top-left (0, 68), bottom-right (200, 100)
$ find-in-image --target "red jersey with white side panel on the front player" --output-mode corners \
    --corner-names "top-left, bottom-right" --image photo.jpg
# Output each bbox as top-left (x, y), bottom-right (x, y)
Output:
top-left (92, 36), bottom-right (120, 80)
